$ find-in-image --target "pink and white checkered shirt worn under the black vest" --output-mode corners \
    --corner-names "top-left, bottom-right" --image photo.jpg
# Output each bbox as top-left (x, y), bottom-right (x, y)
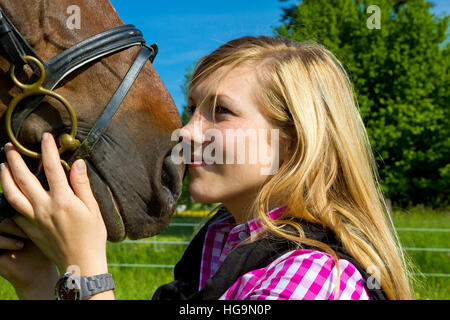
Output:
top-left (199, 207), bottom-right (370, 300)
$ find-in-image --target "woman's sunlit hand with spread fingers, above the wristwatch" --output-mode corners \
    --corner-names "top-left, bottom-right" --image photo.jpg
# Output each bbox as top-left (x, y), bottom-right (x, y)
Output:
top-left (0, 133), bottom-right (108, 276)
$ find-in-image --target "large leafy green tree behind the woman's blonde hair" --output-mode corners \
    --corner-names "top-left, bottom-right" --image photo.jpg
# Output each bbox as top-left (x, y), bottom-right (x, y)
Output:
top-left (275, 0), bottom-right (450, 206)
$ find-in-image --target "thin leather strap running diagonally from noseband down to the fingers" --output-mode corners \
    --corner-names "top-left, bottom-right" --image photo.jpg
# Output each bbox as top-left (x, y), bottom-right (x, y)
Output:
top-left (67, 47), bottom-right (154, 166)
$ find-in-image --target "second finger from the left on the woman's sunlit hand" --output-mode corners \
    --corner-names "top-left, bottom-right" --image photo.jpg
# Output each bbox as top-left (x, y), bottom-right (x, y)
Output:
top-left (5, 142), bottom-right (48, 204)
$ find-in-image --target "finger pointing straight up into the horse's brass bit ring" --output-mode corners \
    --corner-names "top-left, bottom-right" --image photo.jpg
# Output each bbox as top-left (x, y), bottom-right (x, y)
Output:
top-left (41, 132), bottom-right (70, 193)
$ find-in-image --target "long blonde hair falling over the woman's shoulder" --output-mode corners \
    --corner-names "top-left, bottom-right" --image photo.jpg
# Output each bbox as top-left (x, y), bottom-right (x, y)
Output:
top-left (189, 36), bottom-right (412, 299)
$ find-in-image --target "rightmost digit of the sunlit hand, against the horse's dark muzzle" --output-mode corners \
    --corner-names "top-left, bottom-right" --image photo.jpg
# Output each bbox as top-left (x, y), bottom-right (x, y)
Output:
top-left (70, 159), bottom-right (98, 212)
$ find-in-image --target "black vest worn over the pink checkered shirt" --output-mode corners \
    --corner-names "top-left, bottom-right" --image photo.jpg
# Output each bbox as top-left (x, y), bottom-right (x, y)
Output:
top-left (153, 208), bottom-right (386, 300)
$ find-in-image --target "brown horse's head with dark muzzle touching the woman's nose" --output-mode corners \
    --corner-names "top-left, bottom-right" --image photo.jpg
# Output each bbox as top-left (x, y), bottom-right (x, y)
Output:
top-left (0, 0), bottom-right (185, 241)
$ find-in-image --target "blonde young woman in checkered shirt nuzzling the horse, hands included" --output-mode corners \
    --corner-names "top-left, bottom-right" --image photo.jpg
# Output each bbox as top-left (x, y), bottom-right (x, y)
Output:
top-left (0, 36), bottom-right (411, 299)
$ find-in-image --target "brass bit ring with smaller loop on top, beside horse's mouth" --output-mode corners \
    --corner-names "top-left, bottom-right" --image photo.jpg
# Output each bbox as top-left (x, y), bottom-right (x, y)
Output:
top-left (5, 56), bottom-right (80, 171)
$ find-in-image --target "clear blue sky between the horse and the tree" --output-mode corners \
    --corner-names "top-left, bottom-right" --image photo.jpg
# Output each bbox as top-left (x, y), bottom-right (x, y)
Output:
top-left (111, 0), bottom-right (450, 114)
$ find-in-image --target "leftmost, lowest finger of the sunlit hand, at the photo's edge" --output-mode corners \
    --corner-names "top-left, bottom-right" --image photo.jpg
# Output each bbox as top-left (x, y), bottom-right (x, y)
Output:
top-left (0, 163), bottom-right (34, 218)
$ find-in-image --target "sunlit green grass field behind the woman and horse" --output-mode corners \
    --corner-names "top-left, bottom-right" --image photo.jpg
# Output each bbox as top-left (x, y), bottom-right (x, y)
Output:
top-left (0, 208), bottom-right (450, 300)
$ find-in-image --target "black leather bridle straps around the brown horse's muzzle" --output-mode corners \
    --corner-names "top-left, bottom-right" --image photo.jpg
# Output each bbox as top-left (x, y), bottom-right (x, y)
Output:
top-left (0, 8), bottom-right (158, 222)
